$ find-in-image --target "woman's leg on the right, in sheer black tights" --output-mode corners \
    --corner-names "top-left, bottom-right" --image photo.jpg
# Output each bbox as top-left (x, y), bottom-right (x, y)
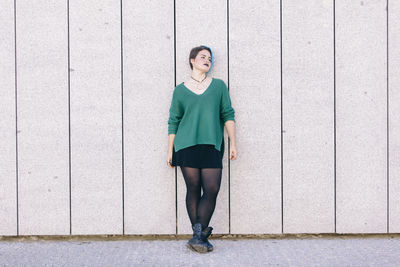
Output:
top-left (197, 168), bottom-right (222, 229)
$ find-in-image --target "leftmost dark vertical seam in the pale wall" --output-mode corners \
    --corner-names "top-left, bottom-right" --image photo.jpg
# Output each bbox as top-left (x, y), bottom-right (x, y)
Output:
top-left (14, 0), bottom-right (19, 235)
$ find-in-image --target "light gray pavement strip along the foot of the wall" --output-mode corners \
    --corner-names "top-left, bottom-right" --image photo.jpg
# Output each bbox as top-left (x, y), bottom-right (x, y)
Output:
top-left (0, 236), bottom-right (400, 266)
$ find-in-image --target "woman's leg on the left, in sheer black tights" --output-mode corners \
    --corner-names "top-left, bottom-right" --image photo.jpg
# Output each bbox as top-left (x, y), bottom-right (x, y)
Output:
top-left (181, 166), bottom-right (201, 225)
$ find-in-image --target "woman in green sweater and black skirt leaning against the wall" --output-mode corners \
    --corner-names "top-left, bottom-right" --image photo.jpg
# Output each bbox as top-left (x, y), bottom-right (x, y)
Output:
top-left (167, 46), bottom-right (237, 253)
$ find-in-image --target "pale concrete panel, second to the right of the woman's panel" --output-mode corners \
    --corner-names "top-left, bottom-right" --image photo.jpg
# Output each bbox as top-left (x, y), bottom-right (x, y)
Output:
top-left (282, 0), bottom-right (335, 233)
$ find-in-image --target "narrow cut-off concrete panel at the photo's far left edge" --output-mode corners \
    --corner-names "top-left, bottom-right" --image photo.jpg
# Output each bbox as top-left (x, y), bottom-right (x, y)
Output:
top-left (0, 0), bottom-right (17, 235)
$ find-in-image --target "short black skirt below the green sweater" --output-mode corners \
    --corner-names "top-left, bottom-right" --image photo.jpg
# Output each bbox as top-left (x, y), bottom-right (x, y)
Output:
top-left (171, 144), bottom-right (222, 169)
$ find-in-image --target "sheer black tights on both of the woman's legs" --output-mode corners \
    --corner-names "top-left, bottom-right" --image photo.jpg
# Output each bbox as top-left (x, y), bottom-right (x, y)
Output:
top-left (180, 166), bottom-right (222, 229)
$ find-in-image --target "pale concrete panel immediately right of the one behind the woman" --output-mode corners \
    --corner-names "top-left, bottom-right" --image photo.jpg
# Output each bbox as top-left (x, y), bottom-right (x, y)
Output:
top-left (226, 0), bottom-right (282, 234)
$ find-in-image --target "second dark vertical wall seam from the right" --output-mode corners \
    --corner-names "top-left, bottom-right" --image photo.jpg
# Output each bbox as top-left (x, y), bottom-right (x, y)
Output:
top-left (333, 0), bottom-right (336, 233)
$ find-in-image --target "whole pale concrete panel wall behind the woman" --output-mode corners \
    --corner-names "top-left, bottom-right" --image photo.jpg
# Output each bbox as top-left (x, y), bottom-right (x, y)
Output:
top-left (0, 0), bottom-right (400, 236)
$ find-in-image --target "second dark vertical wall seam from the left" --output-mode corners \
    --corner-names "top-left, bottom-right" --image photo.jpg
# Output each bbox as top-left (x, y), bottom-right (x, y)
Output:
top-left (67, 0), bottom-right (72, 235)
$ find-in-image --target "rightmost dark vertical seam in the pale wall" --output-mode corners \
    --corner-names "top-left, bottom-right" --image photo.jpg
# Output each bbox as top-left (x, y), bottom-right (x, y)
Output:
top-left (386, 0), bottom-right (390, 233)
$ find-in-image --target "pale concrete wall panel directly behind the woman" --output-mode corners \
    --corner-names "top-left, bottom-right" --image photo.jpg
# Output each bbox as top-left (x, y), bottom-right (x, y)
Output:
top-left (177, 0), bottom-right (230, 234)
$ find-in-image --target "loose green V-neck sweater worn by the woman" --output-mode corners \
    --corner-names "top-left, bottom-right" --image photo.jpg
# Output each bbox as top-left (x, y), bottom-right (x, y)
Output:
top-left (168, 78), bottom-right (235, 156)
